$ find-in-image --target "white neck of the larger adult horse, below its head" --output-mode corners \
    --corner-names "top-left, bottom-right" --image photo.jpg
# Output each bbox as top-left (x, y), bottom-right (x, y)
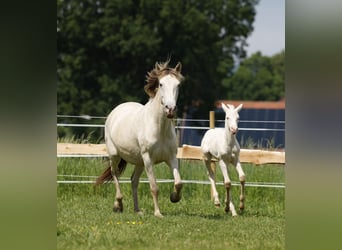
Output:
top-left (146, 92), bottom-right (172, 133)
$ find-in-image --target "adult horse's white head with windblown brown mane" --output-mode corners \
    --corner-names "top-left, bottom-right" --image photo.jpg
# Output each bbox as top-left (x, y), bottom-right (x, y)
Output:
top-left (144, 60), bottom-right (183, 118)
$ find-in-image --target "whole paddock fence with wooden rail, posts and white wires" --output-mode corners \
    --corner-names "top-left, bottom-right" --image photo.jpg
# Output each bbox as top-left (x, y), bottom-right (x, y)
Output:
top-left (57, 112), bottom-right (285, 188)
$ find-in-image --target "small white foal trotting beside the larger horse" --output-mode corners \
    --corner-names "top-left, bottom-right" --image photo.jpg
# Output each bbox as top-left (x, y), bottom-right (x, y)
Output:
top-left (201, 103), bottom-right (245, 216)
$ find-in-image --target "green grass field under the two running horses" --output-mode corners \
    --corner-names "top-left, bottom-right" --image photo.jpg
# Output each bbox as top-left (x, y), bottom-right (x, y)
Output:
top-left (57, 158), bottom-right (285, 250)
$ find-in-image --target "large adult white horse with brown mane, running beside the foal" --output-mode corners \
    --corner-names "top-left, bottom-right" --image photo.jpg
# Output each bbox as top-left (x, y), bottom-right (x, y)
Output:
top-left (96, 60), bottom-right (183, 217)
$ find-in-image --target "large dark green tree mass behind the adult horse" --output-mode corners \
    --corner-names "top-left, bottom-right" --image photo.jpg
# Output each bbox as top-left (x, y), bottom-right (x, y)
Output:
top-left (57, 0), bottom-right (258, 139)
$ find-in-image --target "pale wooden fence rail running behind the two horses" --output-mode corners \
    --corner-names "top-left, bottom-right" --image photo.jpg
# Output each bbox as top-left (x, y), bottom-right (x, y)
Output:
top-left (57, 143), bottom-right (285, 165)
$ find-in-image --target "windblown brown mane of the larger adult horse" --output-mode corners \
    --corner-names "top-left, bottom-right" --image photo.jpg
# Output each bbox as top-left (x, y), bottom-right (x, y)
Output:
top-left (144, 59), bottom-right (183, 98)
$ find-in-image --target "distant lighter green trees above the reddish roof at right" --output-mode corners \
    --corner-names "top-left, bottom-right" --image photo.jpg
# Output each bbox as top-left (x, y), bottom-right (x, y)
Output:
top-left (223, 51), bottom-right (285, 101)
